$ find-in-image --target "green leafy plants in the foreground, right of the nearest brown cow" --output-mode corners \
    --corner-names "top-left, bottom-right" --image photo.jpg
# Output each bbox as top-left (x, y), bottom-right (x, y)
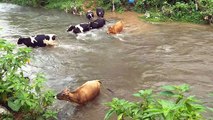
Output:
top-left (105, 84), bottom-right (208, 120)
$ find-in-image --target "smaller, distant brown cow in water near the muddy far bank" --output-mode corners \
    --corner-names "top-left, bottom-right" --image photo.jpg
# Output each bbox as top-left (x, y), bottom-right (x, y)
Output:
top-left (107, 21), bottom-right (124, 34)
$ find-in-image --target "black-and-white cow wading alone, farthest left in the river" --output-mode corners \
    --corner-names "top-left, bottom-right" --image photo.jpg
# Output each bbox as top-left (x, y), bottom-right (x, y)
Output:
top-left (17, 34), bottom-right (56, 47)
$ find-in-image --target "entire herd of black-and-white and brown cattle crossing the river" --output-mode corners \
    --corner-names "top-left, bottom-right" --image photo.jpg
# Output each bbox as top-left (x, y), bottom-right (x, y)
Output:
top-left (17, 8), bottom-right (123, 105)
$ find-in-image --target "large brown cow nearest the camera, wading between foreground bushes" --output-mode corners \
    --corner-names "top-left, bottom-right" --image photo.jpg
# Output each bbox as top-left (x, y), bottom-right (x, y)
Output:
top-left (57, 80), bottom-right (101, 104)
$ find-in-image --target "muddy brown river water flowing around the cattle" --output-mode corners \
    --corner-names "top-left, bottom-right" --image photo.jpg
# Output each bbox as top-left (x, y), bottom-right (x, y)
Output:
top-left (0, 3), bottom-right (213, 120)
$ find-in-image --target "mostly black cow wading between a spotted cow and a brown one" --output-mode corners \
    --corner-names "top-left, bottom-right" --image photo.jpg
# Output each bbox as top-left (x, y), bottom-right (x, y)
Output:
top-left (90, 18), bottom-right (106, 29)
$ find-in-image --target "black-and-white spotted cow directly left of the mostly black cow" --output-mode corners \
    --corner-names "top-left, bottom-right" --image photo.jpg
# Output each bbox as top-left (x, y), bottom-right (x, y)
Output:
top-left (67, 23), bottom-right (90, 34)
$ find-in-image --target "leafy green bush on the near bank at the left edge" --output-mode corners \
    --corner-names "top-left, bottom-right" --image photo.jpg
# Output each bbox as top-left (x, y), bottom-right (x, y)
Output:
top-left (0, 39), bottom-right (56, 119)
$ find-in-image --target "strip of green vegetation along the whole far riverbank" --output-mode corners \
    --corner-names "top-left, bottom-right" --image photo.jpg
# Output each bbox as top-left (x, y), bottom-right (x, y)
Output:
top-left (0, 0), bottom-right (213, 23)
